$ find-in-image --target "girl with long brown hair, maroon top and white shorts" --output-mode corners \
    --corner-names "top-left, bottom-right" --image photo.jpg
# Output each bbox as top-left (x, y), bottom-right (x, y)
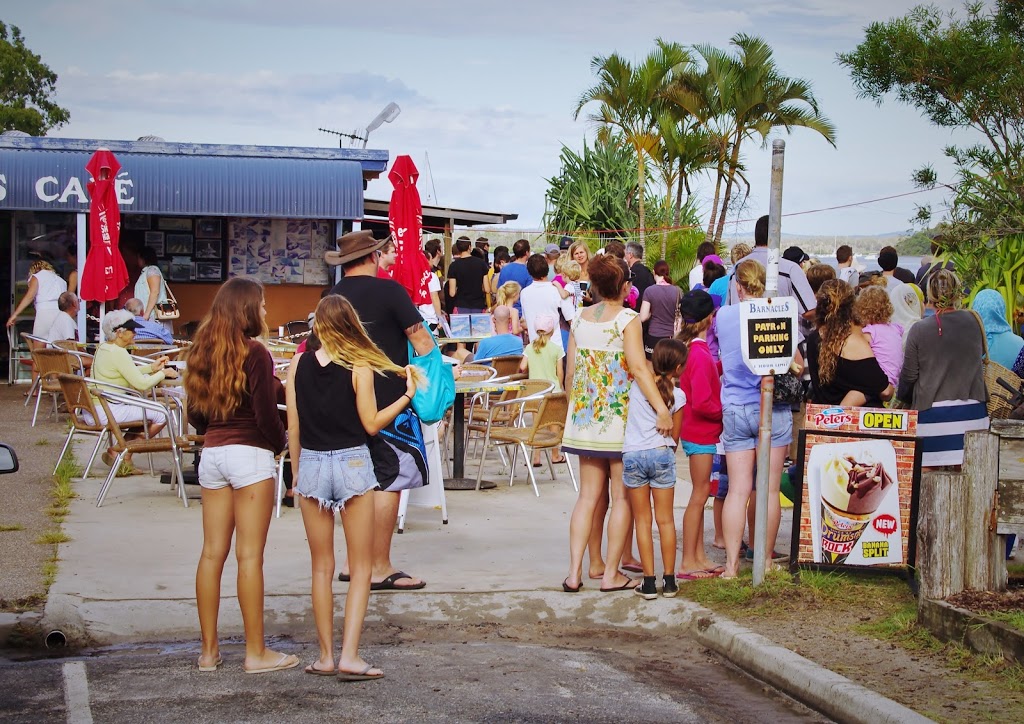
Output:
top-left (184, 276), bottom-right (299, 674)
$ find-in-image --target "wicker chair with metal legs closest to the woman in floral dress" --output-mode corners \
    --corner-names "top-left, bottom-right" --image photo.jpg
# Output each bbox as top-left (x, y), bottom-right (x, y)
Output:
top-left (476, 392), bottom-right (580, 497)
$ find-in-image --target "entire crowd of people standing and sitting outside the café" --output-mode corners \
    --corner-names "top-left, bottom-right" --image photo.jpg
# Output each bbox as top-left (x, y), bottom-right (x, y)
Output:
top-left (14, 222), bottom-right (1007, 680)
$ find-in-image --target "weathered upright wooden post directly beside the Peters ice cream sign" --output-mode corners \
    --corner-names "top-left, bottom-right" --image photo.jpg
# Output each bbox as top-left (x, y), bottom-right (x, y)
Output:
top-left (918, 472), bottom-right (967, 598)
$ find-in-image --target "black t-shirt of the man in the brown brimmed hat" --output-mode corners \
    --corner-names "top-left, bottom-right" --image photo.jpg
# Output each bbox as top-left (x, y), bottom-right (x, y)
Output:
top-left (331, 274), bottom-right (423, 409)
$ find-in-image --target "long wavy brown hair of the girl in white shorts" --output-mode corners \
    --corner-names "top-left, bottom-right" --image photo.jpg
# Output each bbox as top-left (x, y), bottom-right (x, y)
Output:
top-left (184, 276), bottom-right (267, 420)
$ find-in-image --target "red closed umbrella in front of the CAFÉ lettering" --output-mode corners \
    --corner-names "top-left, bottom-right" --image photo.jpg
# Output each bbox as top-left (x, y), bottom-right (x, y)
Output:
top-left (79, 148), bottom-right (128, 303)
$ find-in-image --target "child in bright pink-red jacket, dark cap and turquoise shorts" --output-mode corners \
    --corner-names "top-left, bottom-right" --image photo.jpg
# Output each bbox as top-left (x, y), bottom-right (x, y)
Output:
top-left (676, 290), bottom-right (723, 581)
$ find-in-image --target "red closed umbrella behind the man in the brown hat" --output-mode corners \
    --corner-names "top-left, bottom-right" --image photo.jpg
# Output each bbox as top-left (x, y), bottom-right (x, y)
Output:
top-left (387, 156), bottom-right (433, 306)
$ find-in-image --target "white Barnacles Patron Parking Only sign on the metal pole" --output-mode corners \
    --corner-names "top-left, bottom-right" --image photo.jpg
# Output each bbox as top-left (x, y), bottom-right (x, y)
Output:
top-left (739, 297), bottom-right (797, 376)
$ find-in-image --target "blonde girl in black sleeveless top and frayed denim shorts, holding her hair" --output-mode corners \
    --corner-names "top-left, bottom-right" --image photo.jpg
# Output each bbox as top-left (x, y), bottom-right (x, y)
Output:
top-left (287, 294), bottom-right (416, 681)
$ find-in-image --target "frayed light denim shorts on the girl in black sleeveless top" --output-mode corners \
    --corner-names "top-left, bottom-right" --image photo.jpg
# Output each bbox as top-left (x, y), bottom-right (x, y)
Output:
top-left (295, 445), bottom-right (377, 510)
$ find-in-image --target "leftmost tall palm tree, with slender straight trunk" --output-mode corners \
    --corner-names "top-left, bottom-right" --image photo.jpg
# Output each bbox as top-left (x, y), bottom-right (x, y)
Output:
top-left (572, 38), bottom-right (690, 243)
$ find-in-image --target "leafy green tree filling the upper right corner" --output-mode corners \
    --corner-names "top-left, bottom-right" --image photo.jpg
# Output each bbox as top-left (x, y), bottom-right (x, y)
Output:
top-left (838, 0), bottom-right (1024, 246)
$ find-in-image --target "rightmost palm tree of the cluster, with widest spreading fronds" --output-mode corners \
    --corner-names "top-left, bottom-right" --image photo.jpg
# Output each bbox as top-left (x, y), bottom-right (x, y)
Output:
top-left (668, 33), bottom-right (836, 244)
